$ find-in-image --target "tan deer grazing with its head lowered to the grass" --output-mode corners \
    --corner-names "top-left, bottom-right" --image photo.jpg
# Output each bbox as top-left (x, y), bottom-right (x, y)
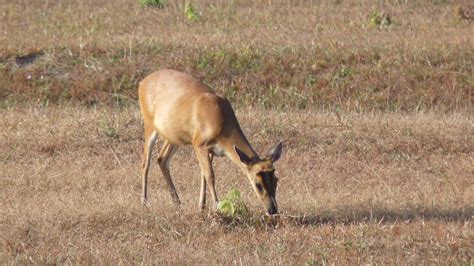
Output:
top-left (138, 70), bottom-right (283, 214)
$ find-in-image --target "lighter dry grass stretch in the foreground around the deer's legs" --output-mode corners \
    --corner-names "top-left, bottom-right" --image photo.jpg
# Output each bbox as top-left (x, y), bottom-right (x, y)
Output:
top-left (0, 106), bottom-right (474, 264)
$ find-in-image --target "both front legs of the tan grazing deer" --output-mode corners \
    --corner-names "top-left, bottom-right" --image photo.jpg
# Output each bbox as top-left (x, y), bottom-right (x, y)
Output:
top-left (194, 147), bottom-right (218, 209)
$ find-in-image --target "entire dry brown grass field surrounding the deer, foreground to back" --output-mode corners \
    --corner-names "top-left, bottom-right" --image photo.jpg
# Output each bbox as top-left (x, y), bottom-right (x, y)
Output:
top-left (0, 0), bottom-right (474, 265)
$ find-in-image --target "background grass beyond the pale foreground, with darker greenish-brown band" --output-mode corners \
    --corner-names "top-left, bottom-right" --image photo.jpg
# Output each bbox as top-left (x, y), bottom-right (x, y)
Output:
top-left (0, 0), bottom-right (474, 111)
